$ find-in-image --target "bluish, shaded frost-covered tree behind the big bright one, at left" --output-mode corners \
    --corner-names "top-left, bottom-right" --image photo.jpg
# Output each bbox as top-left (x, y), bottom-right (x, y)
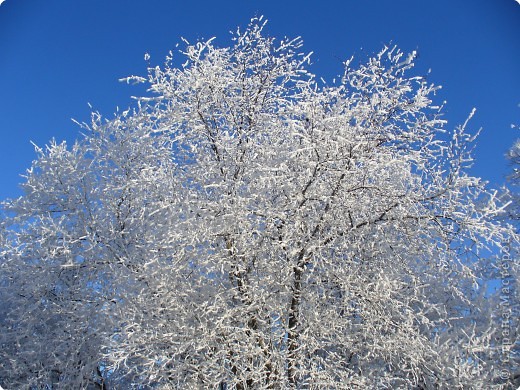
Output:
top-left (0, 112), bottom-right (178, 388)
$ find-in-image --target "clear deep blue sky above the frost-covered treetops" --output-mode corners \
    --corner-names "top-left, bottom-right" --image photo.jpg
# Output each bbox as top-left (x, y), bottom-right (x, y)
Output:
top-left (0, 0), bottom-right (520, 200)
